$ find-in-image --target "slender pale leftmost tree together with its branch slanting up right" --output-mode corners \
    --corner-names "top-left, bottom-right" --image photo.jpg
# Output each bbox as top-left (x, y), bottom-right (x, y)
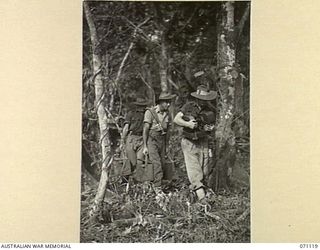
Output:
top-left (83, 2), bottom-right (149, 220)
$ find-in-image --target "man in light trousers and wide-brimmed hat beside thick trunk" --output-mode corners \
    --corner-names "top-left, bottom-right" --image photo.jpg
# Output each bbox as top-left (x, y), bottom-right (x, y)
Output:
top-left (173, 85), bottom-right (217, 200)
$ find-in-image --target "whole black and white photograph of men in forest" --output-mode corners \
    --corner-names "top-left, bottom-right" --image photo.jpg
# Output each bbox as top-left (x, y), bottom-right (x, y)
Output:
top-left (80, 1), bottom-right (251, 243)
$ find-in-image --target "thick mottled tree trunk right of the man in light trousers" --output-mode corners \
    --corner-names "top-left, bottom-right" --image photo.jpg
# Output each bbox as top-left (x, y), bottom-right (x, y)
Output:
top-left (215, 2), bottom-right (238, 189)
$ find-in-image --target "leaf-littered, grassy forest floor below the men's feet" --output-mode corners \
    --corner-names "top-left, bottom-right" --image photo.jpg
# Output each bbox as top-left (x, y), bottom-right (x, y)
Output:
top-left (80, 156), bottom-right (250, 243)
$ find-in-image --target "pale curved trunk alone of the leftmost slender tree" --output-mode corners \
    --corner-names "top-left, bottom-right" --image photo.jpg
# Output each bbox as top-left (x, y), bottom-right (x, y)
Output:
top-left (83, 2), bottom-right (113, 220)
